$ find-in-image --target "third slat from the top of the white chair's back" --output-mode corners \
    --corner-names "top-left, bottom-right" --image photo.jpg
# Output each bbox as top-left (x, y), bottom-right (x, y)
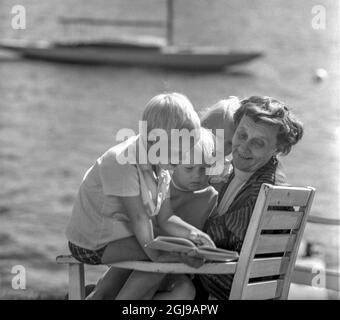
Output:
top-left (256, 234), bottom-right (296, 254)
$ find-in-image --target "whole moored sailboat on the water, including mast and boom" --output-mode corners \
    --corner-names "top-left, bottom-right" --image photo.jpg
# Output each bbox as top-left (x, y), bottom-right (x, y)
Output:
top-left (0, 0), bottom-right (263, 71)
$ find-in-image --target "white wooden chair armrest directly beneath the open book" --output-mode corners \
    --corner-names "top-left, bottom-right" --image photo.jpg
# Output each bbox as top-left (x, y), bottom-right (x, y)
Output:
top-left (111, 261), bottom-right (237, 274)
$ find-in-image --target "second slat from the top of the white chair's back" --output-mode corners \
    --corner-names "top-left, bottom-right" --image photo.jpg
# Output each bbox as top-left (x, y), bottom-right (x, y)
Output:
top-left (262, 210), bottom-right (303, 230)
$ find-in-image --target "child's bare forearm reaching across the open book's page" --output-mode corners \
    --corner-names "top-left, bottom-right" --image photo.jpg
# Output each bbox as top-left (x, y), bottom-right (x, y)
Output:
top-left (157, 198), bottom-right (215, 247)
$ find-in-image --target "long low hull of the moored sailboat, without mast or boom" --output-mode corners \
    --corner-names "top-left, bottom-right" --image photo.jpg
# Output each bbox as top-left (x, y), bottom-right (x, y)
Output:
top-left (0, 38), bottom-right (262, 71)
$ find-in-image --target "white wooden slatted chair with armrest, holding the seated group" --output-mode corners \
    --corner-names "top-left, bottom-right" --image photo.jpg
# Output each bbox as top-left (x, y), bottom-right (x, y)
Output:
top-left (57, 184), bottom-right (315, 299)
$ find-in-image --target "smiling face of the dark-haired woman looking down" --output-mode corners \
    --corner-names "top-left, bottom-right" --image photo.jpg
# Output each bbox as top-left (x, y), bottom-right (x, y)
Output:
top-left (232, 116), bottom-right (279, 172)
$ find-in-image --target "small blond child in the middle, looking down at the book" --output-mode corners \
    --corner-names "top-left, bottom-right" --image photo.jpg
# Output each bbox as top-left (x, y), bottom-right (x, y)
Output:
top-left (116, 128), bottom-right (218, 300)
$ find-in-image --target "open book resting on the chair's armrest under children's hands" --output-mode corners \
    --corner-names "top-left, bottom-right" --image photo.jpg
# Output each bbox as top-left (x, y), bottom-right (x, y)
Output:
top-left (146, 236), bottom-right (239, 261)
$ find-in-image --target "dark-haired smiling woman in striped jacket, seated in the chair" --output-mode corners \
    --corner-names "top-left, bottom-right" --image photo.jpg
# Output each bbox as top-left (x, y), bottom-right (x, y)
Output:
top-left (194, 96), bottom-right (303, 299)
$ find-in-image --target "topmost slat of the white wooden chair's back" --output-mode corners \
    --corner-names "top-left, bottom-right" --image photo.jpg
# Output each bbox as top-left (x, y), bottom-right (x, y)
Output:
top-left (269, 188), bottom-right (311, 206)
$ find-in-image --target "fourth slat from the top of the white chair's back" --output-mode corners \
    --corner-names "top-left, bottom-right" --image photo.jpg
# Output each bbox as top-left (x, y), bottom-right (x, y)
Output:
top-left (250, 257), bottom-right (289, 278)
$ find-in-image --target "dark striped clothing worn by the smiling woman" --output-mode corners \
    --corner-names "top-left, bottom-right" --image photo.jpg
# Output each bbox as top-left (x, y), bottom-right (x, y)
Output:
top-left (199, 157), bottom-right (278, 300)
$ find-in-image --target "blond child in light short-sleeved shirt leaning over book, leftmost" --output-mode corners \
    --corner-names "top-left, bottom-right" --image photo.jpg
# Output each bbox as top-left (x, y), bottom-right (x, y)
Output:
top-left (66, 93), bottom-right (213, 296)
